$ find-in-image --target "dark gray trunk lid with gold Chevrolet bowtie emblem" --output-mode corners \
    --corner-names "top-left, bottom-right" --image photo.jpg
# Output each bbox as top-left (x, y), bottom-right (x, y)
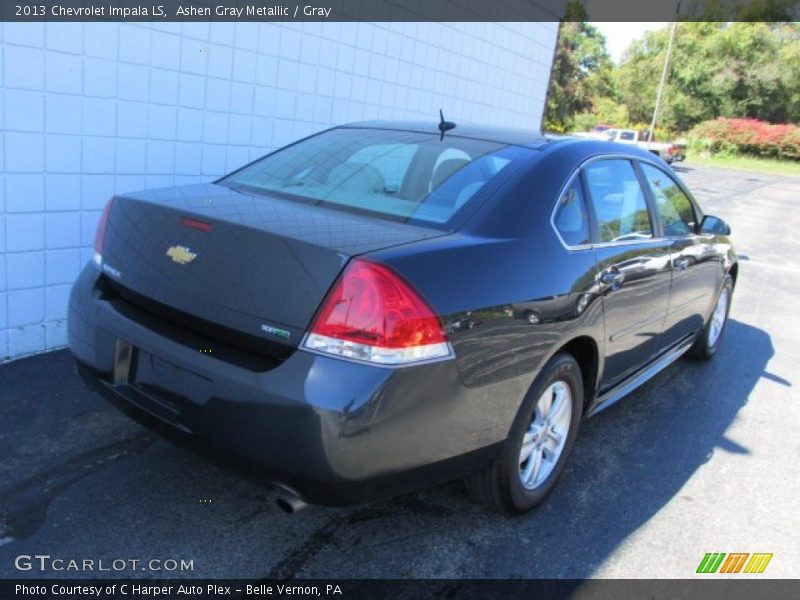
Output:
top-left (103, 184), bottom-right (445, 354)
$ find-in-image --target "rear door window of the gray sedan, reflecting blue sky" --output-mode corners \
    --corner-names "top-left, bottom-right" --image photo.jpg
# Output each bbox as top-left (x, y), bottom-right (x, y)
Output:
top-left (584, 159), bottom-right (653, 242)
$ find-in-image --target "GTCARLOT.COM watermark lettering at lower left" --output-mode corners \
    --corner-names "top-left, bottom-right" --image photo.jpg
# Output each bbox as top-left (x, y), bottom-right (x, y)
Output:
top-left (14, 554), bottom-right (194, 573)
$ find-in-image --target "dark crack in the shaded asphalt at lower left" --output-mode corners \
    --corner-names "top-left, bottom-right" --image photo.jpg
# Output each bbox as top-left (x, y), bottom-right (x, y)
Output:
top-left (0, 435), bottom-right (155, 543)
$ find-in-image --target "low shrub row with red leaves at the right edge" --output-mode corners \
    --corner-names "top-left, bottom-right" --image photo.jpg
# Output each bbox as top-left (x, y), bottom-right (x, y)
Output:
top-left (687, 117), bottom-right (800, 160)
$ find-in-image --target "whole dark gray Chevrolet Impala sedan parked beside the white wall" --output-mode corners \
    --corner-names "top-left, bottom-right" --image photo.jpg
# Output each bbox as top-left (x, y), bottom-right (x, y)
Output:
top-left (69, 120), bottom-right (738, 514)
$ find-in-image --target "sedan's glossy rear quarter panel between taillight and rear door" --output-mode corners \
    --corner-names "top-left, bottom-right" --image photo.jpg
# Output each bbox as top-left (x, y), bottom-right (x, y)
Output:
top-left (370, 145), bottom-right (604, 402)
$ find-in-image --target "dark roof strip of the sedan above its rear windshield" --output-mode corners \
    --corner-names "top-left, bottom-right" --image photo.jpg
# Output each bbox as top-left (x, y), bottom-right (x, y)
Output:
top-left (342, 119), bottom-right (551, 148)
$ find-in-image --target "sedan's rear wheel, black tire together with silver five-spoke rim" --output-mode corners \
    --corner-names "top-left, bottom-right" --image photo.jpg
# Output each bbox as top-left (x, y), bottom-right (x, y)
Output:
top-left (466, 354), bottom-right (583, 514)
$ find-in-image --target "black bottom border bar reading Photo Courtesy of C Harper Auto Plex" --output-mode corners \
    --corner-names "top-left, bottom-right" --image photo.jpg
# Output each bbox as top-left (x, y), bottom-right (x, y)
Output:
top-left (0, 575), bottom-right (800, 600)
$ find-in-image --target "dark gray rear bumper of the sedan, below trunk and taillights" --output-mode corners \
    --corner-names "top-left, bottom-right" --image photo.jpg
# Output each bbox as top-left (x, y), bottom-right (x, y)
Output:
top-left (68, 265), bottom-right (510, 504)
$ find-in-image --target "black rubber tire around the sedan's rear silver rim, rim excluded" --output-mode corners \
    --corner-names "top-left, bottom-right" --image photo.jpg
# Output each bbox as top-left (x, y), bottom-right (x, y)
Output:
top-left (465, 354), bottom-right (584, 515)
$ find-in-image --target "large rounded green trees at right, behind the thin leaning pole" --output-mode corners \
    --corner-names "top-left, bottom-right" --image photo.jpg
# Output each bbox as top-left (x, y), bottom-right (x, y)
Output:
top-left (613, 22), bottom-right (800, 131)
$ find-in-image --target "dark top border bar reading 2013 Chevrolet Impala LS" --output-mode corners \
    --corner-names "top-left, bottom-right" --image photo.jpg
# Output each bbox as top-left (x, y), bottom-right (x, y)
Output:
top-left (0, 0), bottom-right (800, 22)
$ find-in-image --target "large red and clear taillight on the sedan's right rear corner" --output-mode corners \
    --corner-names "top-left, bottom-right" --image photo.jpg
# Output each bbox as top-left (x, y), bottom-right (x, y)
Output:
top-left (305, 259), bottom-right (450, 364)
